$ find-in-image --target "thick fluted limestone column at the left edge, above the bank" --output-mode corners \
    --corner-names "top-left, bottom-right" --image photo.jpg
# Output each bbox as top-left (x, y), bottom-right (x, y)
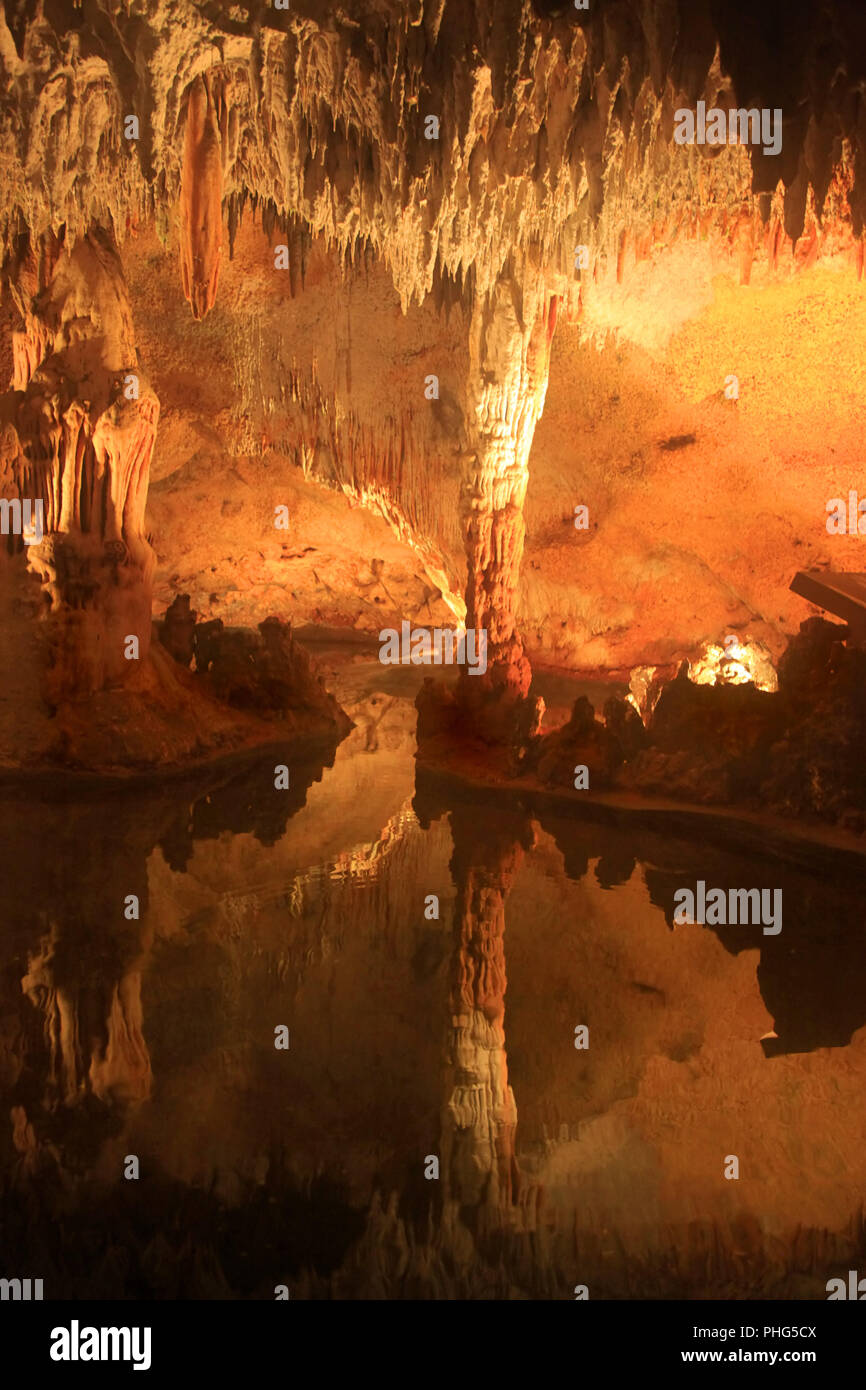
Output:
top-left (0, 231), bottom-right (158, 703)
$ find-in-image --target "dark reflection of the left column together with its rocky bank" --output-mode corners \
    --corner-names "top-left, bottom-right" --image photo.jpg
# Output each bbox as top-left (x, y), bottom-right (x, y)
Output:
top-left (0, 759), bottom-right (339, 1168)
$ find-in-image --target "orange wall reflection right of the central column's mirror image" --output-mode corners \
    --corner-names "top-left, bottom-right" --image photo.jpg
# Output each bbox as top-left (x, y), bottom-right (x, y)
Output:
top-left (507, 816), bottom-right (866, 1297)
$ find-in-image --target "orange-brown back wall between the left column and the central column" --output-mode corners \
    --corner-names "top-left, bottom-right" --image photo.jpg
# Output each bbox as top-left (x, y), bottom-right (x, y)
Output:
top-left (125, 217), bottom-right (467, 632)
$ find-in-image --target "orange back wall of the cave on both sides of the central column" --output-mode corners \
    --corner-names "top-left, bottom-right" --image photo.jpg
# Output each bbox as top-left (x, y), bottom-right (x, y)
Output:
top-left (118, 211), bottom-right (866, 674)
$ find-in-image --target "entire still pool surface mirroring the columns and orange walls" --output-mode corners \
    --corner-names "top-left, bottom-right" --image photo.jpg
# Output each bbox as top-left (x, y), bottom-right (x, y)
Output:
top-left (0, 689), bottom-right (866, 1298)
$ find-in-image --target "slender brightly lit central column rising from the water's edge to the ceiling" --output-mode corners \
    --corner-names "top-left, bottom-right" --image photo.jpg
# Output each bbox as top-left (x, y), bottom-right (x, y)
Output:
top-left (460, 272), bottom-right (556, 741)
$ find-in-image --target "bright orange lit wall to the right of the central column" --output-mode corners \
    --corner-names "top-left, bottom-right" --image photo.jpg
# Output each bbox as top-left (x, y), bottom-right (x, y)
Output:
top-left (518, 243), bottom-right (866, 673)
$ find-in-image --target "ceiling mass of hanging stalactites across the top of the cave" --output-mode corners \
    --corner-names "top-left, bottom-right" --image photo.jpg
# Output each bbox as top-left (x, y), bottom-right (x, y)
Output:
top-left (0, 0), bottom-right (866, 304)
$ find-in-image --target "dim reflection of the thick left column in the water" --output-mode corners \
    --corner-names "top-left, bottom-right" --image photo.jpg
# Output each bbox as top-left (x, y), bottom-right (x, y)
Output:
top-left (3, 798), bottom-right (159, 1170)
